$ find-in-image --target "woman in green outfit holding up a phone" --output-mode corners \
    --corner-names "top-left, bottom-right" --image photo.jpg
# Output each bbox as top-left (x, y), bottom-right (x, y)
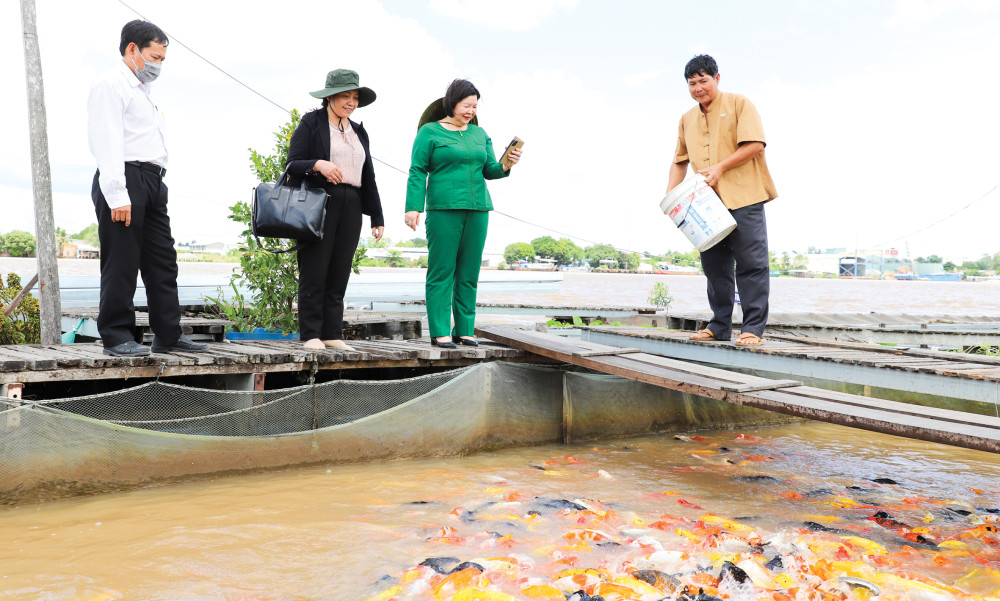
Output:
top-left (406, 79), bottom-right (521, 348)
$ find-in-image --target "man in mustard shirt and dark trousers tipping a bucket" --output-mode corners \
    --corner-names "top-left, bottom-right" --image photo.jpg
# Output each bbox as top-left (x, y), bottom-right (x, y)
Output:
top-left (667, 54), bottom-right (778, 346)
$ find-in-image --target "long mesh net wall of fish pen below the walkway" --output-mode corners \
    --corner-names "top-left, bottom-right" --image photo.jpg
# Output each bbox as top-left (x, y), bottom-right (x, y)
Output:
top-left (0, 362), bottom-right (787, 504)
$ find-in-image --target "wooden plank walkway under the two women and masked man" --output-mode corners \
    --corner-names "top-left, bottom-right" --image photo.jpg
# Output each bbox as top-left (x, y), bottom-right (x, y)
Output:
top-left (0, 338), bottom-right (538, 384)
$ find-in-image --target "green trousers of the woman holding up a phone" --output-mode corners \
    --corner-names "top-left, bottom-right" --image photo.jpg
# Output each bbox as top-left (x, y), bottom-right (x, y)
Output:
top-left (425, 209), bottom-right (490, 337)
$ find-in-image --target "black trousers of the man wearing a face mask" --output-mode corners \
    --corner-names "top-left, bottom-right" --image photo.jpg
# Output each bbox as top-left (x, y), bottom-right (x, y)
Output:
top-left (90, 164), bottom-right (181, 347)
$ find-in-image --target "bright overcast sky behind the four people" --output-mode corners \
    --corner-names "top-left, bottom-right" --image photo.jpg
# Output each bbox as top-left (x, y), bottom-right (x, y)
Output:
top-left (0, 0), bottom-right (1000, 258)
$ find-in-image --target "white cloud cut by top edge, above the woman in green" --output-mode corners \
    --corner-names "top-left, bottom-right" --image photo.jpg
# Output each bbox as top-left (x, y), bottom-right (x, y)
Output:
top-left (430, 0), bottom-right (577, 31)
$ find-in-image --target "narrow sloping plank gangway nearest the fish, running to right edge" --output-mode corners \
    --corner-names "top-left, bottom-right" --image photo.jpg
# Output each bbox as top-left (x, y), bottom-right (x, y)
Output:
top-left (476, 326), bottom-right (1000, 453)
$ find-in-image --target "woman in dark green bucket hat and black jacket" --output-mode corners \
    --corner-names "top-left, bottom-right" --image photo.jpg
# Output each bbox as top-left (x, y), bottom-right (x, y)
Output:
top-left (287, 69), bottom-right (385, 350)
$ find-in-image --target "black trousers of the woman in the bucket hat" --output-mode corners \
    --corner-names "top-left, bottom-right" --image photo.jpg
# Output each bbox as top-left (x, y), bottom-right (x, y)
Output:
top-left (298, 184), bottom-right (361, 340)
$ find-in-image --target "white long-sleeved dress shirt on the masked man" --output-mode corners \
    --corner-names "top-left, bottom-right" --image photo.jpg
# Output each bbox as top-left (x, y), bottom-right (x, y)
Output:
top-left (87, 62), bottom-right (167, 209)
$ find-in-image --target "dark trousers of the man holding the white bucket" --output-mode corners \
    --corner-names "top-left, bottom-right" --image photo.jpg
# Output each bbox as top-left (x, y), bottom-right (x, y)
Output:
top-left (701, 202), bottom-right (771, 340)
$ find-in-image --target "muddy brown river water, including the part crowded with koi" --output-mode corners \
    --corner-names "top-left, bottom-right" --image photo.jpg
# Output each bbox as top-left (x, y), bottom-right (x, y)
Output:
top-left (0, 259), bottom-right (1000, 601)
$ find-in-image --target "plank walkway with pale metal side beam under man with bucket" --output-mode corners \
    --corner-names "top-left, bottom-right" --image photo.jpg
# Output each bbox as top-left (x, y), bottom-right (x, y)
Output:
top-left (581, 327), bottom-right (1000, 405)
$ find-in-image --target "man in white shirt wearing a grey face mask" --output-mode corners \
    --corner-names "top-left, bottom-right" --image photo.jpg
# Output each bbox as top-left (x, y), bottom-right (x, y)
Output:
top-left (87, 20), bottom-right (207, 357)
